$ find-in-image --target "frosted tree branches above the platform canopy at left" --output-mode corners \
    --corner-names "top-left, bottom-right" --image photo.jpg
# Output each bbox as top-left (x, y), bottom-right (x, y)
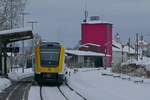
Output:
top-left (0, 0), bottom-right (27, 30)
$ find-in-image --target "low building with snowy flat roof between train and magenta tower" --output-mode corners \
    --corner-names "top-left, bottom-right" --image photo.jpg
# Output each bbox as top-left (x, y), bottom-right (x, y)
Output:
top-left (65, 50), bottom-right (109, 67)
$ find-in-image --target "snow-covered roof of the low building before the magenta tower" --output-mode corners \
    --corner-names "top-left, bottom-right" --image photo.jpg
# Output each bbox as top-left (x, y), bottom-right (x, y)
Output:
top-left (65, 50), bottom-right (110, 57)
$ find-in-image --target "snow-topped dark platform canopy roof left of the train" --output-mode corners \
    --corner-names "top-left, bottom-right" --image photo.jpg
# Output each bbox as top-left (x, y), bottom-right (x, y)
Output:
top-left (0, 28), bottom-right (33, 43)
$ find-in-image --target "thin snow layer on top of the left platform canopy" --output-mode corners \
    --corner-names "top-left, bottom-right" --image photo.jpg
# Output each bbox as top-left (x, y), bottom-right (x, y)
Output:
top-left (0, 27), bottom-right (32, 34)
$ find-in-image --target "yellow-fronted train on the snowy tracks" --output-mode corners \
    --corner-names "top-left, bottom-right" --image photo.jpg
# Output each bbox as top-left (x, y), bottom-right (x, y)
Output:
top-left (34, 42), bottom-right (66, 84)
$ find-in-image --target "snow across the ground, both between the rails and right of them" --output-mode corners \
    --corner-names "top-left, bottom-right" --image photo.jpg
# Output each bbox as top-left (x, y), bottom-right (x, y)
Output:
top-left (28, 68), bottom-right (150, 100)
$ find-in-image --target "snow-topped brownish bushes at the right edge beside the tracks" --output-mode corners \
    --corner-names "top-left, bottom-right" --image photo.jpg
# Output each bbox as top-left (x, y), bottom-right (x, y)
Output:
top-left (112, 57), bottom-right (150, 77)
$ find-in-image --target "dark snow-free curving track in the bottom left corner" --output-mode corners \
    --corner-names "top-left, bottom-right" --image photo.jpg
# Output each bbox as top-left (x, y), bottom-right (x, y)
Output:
top-left (0, 77), bottom-right (32, 100)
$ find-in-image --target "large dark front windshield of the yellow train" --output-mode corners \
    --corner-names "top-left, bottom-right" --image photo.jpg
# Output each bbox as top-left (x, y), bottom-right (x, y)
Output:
top-left (40, 48), bottom-right (60, 67)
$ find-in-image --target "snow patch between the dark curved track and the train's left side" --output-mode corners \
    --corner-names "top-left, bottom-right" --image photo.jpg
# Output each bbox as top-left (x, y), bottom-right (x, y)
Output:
top-left (8, 68), bottom-right (33, 81)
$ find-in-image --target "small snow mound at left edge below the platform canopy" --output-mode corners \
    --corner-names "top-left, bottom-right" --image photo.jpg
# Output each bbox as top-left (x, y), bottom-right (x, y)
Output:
top-left (0, 77), bottom-right (11, 92)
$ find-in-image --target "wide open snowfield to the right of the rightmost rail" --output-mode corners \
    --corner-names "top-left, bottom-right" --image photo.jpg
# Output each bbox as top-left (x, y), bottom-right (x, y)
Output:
top-left (68, 70), bottom-right (150, 100)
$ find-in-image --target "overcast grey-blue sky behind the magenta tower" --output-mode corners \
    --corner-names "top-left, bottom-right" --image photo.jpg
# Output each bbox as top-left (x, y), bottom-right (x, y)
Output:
top-left (25, 0), bottom-right (150, 47)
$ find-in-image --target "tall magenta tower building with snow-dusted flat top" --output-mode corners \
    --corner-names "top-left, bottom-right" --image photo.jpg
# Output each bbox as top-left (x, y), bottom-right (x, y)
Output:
top-left (81, 16), bottom-right (112, 67)
